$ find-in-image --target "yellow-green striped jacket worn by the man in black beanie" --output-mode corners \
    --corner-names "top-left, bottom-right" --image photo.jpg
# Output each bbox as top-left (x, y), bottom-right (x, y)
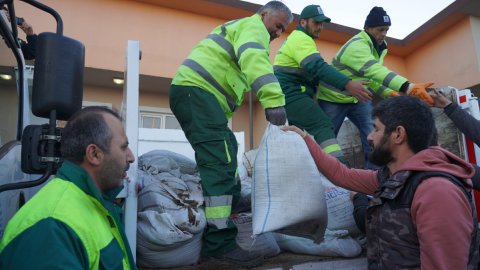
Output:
top-left (318, 31), bottom-right (407, 103)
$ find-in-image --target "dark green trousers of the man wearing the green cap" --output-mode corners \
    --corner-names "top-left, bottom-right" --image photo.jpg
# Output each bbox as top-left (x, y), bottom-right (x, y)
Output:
top-left (285, 95), bottom-right (347, 164)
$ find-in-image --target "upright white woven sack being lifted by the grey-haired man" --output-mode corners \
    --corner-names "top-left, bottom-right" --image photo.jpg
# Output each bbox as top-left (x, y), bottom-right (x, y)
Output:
top-left (252, 125), bottom-right (327, 242)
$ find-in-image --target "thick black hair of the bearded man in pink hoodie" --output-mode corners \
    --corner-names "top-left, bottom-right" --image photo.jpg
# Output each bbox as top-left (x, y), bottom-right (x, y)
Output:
top-left (372, 96), bottom-right (435, 153)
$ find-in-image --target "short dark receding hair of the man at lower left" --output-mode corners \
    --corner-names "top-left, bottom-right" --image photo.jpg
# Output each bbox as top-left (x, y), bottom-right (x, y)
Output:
top-left (60, 106), bottom-right (120, 164)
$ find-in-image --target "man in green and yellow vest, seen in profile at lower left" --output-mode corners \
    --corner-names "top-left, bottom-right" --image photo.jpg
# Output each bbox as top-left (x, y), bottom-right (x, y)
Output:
top-left (0, 107), bottom-right (136, 270)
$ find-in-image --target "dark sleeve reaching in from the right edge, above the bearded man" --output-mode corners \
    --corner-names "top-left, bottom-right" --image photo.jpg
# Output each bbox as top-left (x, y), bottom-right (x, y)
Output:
top-left (444, 102), bottom-right (480, 146)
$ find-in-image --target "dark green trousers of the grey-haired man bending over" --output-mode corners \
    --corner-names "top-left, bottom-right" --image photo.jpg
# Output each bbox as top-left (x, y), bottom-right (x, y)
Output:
top-left (169, 85), bottom-right (240, 256)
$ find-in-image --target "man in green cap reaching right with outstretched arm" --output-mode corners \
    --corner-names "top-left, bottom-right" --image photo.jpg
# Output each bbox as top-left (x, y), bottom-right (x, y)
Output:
top-left (274, 5), bottom-right (371, 163)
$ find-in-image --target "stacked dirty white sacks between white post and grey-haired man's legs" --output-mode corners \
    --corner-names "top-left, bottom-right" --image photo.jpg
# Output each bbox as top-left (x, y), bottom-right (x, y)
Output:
top-left (137, 150), bottom-right (206, 268)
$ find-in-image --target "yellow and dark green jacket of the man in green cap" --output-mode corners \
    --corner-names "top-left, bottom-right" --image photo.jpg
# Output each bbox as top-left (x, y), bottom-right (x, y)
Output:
top-left (274, 30), bottom-right (350, 101)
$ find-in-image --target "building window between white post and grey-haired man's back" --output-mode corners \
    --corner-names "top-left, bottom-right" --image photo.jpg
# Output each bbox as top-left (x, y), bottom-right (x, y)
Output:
top-left (139, 107), bottom-right (181, 129)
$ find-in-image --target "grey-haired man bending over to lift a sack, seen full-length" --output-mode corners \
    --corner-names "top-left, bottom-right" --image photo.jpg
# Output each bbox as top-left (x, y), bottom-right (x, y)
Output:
top-left (169, 1), bottom-right (293, 267)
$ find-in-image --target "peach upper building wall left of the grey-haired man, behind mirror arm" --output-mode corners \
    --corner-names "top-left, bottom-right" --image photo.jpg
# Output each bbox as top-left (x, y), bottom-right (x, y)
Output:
top-left (13, 0), bottom-right (246, 78)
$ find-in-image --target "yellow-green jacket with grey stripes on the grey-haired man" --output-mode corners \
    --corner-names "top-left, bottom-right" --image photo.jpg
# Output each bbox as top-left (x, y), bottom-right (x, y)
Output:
top-left (172, 14), bottom-right (285, 118)
